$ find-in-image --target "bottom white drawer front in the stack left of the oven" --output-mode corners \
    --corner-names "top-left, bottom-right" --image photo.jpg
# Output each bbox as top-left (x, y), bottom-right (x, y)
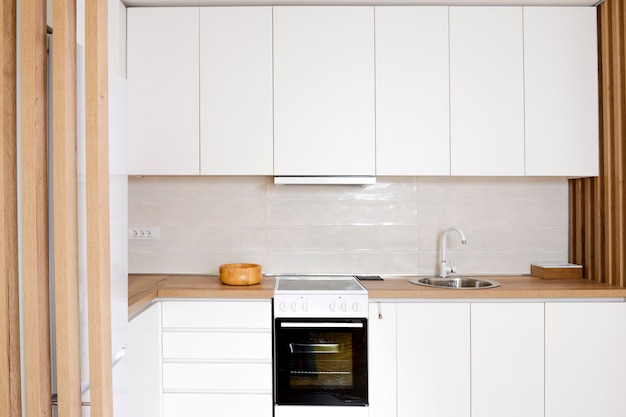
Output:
top-left (163, 394), bottom-right (273, 417)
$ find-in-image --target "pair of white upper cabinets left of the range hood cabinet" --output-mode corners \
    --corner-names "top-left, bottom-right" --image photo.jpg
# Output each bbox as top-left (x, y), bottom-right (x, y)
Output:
top-left (128, 7), bottom-right (273, 175)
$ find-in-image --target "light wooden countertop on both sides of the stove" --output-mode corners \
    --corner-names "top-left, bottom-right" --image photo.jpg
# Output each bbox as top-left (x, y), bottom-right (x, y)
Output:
top-left (128, 274), bottom-right (626, 315)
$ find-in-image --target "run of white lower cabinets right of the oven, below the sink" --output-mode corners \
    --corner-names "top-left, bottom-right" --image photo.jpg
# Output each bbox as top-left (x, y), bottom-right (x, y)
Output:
top-left (382, 300), bottom-right (626, 417)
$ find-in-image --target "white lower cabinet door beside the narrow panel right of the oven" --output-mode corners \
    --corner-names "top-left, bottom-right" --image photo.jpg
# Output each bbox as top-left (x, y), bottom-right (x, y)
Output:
top-left (397, 303), bottom-right (470, 417)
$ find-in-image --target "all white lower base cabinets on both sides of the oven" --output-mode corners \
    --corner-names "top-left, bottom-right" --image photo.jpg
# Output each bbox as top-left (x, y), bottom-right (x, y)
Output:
top-left (133, 300), bottom-right (626, 417)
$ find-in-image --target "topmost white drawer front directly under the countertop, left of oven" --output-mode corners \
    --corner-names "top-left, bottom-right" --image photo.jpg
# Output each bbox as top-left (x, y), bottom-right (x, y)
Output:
top-left (163, 301), bottom-right (272, 329)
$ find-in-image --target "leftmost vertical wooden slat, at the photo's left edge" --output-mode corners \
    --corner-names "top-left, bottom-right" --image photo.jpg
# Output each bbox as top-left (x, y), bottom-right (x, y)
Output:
top-left (0, 0), bottom-right (22, 417)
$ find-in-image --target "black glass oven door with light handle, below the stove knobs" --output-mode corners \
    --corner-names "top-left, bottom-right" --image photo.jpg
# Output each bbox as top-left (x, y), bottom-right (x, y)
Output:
top-left (274, 318), bottom-right (368, 406)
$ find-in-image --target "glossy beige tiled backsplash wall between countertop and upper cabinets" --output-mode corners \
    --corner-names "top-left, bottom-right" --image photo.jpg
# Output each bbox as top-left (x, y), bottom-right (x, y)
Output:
top-left (128, 177), bottom-right (568, 274)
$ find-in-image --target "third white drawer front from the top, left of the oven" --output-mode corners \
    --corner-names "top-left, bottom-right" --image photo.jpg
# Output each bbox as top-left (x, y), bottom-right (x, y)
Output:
top-left (163, 363), bottom-right (272, 393)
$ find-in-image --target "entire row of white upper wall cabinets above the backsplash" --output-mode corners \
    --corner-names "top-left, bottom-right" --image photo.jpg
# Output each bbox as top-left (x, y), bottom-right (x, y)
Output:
top-left (127, 6), bottom-right (599, 177)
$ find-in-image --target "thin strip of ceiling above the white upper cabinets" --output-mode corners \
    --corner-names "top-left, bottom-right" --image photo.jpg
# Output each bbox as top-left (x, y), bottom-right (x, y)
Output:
top-left (122, 0), bottom-right (604, 6)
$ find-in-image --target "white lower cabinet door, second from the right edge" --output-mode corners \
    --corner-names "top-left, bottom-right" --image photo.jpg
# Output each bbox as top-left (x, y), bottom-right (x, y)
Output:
top-left (471, 303), bottom-right (544, 417)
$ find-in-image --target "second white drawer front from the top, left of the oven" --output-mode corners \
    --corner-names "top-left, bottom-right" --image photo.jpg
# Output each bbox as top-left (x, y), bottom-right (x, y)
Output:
top-left (163, 332), bottom-right (272, 361)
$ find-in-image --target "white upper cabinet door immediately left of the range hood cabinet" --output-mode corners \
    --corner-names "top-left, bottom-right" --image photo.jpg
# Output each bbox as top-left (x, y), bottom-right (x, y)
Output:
top-left (200, 7), bottom-right (273, 175)
